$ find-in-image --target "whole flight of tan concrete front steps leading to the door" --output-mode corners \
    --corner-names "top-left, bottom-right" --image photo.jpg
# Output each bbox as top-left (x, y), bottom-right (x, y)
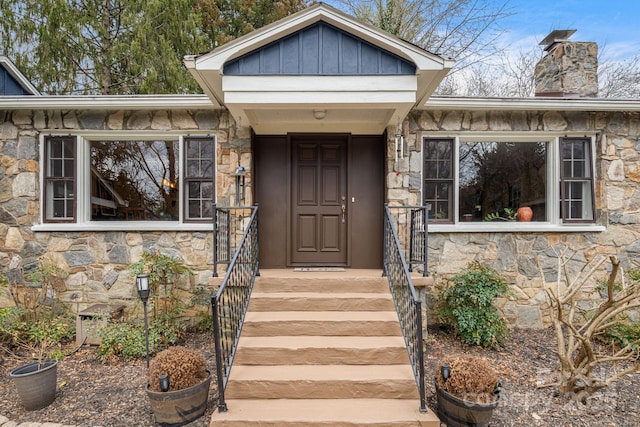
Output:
top-left (211, 270), bottom-right (440, 427)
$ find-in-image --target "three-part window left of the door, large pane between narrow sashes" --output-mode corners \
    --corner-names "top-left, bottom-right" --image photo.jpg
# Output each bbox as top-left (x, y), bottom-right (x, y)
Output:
top-left (43, 134), bottom-right (215, 226)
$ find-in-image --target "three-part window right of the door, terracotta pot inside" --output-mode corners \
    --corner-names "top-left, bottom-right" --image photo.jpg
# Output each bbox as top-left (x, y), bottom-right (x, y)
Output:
top-left (423, 135), bottom-right (595, 226)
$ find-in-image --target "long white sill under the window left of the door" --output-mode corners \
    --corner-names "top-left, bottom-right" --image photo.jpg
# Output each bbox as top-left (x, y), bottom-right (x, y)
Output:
top-left (31, 221), bottom-right (213, 232)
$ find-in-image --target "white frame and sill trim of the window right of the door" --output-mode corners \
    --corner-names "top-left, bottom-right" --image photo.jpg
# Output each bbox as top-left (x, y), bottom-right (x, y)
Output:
top-left (419, 132), bottom-right (606, 233)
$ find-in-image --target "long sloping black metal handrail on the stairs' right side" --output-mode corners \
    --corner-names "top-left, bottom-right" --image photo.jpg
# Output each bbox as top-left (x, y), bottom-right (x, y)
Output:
top-left (383, 206), bottom-right (427, 412)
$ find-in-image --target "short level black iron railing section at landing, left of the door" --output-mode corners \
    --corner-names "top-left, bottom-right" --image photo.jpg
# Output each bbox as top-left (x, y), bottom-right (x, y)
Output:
top-left (213, 205), bottom-right (254, 277)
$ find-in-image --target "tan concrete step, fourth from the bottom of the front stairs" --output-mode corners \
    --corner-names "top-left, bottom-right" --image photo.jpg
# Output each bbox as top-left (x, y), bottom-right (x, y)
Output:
top-left (242, 311), bottom-right (402, 337)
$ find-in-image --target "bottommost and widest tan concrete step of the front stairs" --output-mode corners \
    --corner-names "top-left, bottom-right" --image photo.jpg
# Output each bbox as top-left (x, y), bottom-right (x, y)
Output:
top-left (210, 399), bottom-right (440, 427)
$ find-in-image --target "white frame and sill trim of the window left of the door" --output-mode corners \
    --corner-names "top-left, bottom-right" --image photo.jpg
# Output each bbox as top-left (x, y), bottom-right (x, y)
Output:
top-left (31, 130), bottom-right (218, 232)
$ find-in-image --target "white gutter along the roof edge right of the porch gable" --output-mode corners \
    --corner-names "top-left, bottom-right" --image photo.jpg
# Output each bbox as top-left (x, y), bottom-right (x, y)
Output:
top-left (417, 96), bottom-right (640, 111)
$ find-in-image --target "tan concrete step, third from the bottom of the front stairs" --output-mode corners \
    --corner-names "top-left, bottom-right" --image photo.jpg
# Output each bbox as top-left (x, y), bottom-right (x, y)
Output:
top-left (232, 335), bottom-right (409, 371)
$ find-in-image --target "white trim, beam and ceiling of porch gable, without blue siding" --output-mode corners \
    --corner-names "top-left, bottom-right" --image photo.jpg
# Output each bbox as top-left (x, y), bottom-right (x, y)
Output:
top-left (184, 3), bottom-right (453, 134)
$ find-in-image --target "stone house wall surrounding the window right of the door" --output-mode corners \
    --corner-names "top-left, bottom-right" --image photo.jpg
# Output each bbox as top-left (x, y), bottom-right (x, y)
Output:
top-left (387, 111), bottom-right (640, 328)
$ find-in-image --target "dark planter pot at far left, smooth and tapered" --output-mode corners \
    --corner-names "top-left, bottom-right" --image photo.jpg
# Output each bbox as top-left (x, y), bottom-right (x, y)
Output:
top-left (9, 360), bottom-right (58, 411)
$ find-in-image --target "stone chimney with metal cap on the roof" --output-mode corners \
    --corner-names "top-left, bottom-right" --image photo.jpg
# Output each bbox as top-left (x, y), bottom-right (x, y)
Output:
top-left (535, 30), bottom-right (598, 98)
